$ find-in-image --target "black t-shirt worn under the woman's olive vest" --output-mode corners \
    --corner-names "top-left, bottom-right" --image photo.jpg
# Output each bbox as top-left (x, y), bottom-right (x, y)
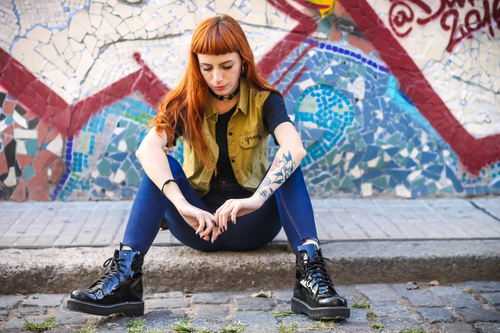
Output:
top-left (212, 92), bottom-right (290, 180)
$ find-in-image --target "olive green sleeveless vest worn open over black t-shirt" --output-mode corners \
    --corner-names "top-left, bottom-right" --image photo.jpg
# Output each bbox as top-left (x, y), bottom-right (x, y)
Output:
top-left (183, 78), bottom-right (270, 196)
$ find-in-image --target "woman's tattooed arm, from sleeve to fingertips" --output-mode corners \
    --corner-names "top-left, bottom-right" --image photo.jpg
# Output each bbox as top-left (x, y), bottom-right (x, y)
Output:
top-left (215, 122), bottom-right (306, 231)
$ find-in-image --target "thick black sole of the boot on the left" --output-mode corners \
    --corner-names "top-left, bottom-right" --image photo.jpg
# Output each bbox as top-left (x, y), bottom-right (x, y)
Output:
top-left (67, 298), bottom-right (144, 317)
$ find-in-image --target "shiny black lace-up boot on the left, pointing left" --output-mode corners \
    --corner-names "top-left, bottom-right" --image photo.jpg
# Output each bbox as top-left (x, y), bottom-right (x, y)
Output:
top-left (67, 250), bottom-right (144, 317)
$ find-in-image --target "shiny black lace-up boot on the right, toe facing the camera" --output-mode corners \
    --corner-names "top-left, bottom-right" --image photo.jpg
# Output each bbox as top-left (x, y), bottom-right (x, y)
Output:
top-left (292, 244), bottom-right (350, 319)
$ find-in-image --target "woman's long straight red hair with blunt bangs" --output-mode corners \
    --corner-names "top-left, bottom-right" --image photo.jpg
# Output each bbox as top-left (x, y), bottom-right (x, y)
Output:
top-left (151, 15), bottom-right (281, 165)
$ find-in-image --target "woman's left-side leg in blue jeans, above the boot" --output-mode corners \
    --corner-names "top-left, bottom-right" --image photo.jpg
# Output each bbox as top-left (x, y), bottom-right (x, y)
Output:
top-left (122, 155), bottom-right (208, 253)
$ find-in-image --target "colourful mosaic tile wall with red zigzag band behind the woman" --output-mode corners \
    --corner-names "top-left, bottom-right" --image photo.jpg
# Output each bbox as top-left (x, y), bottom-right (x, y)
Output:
top-left (0, 0), bottom-right (500, 202)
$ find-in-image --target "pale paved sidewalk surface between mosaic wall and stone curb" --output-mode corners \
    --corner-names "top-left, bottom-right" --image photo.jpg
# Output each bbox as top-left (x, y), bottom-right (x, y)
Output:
top-left (0, 197), bottom-right (500, 248)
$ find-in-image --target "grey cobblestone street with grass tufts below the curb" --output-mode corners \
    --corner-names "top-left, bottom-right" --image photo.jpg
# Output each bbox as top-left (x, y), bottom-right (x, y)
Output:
top-left (0, 281), bottom-right (500, 333)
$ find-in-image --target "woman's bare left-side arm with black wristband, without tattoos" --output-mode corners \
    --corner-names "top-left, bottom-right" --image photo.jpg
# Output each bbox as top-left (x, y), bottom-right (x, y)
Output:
top-left (135, 128), bottom-right (216, 242)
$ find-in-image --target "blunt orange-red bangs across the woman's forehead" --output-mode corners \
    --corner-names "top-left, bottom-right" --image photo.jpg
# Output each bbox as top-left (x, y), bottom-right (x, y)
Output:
top-left (191, 17), bottom-right (239, 55)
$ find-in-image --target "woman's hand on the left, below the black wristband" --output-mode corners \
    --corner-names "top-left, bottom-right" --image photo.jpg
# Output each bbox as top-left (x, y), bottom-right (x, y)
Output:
top-left (176, 199), bottom-right (220, 243)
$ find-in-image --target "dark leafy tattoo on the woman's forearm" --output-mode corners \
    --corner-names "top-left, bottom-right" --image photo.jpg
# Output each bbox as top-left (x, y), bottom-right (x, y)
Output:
top-left (257, 151), bottom-right (297, 200)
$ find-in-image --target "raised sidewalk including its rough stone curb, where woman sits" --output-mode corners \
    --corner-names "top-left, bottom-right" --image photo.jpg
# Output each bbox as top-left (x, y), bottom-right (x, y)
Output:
top-left (0, 197), bottom-right (500, 294)
